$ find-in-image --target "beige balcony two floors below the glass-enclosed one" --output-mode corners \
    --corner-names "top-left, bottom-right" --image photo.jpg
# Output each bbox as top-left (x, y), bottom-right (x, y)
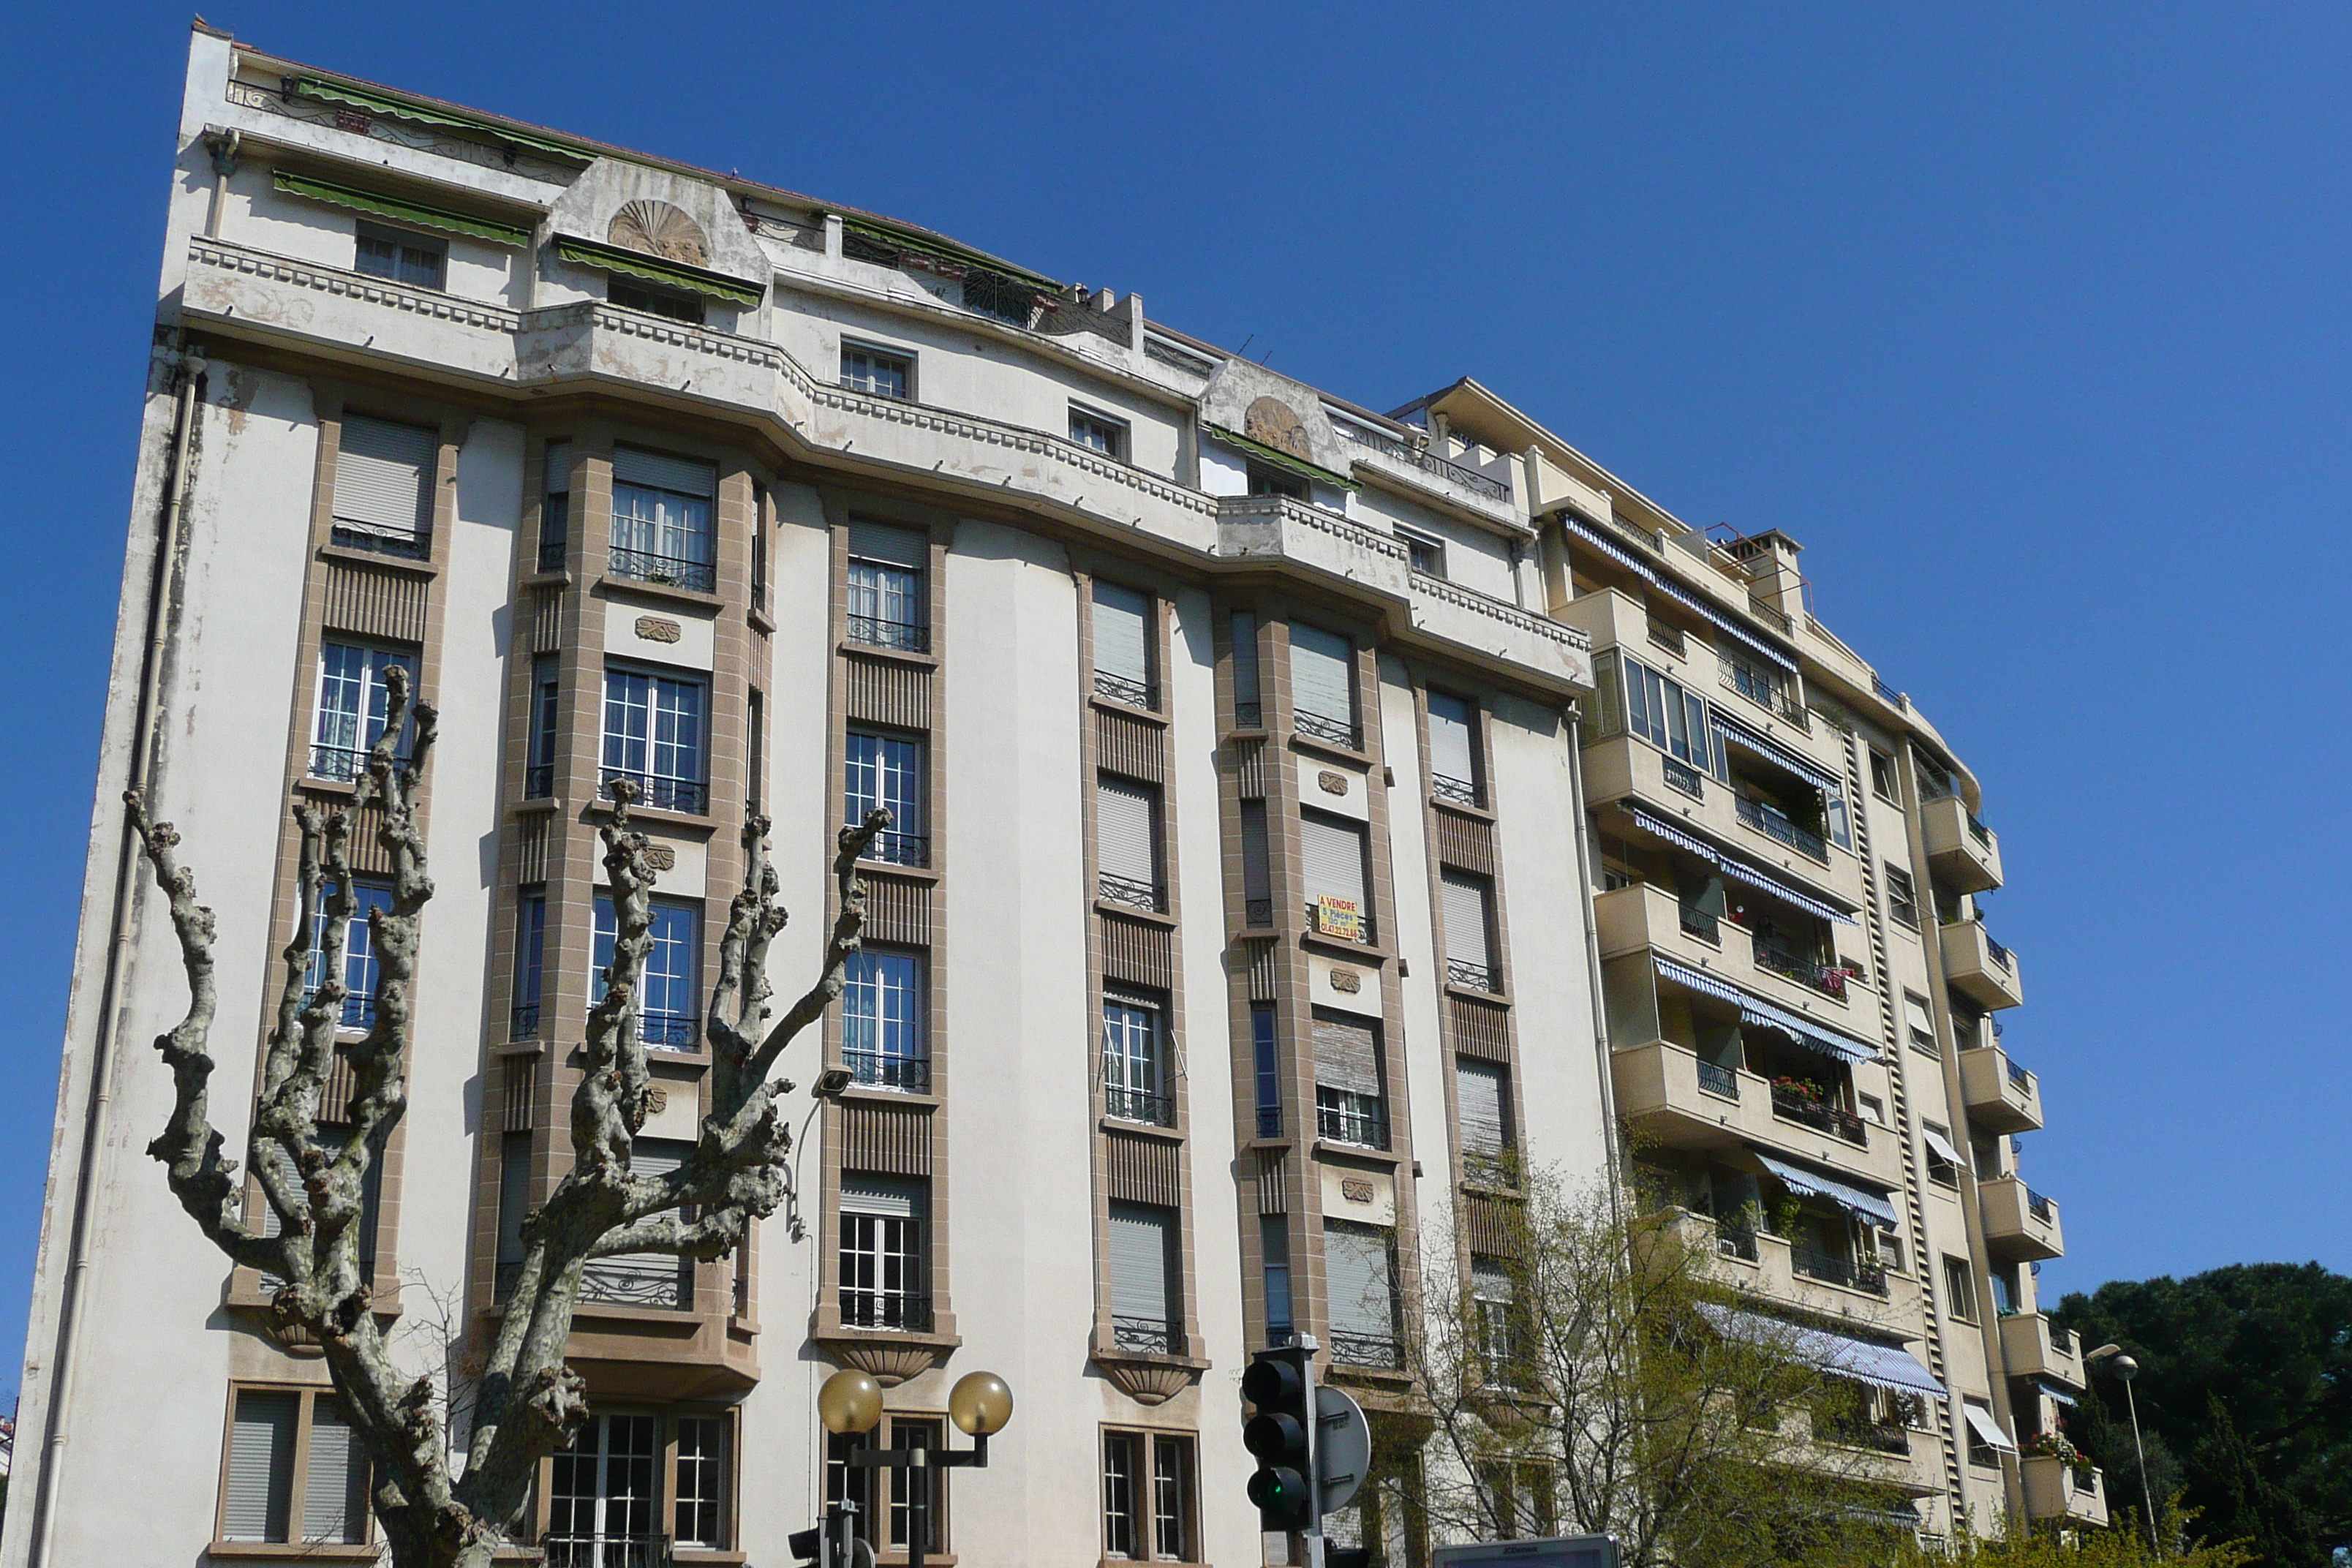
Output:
top-left (1609, 1039), bottom-right (1903, 1187)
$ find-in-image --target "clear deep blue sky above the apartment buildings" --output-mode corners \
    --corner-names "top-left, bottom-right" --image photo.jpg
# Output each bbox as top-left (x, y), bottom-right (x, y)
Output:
top-left (0, 0), bottom-right (2352, 1384)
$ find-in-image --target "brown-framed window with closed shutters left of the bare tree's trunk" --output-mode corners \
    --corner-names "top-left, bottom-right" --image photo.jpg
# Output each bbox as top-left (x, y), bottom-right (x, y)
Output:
top-left (221, 1387), bottom-right (369, 1547)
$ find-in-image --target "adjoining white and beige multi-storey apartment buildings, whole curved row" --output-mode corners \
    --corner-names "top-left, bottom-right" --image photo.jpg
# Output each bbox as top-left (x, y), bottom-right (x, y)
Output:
top-left (0, 23), bottom-right (2103, 1568)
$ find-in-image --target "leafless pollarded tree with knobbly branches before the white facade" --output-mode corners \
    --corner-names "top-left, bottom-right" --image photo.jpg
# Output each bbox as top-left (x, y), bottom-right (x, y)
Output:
top-left (124, 666), bottom-right (892, 1568)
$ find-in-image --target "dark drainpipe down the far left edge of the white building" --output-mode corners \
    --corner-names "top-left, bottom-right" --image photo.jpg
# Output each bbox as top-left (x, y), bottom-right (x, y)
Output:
top-left (29, 343), bottom-right (207, 1568)
